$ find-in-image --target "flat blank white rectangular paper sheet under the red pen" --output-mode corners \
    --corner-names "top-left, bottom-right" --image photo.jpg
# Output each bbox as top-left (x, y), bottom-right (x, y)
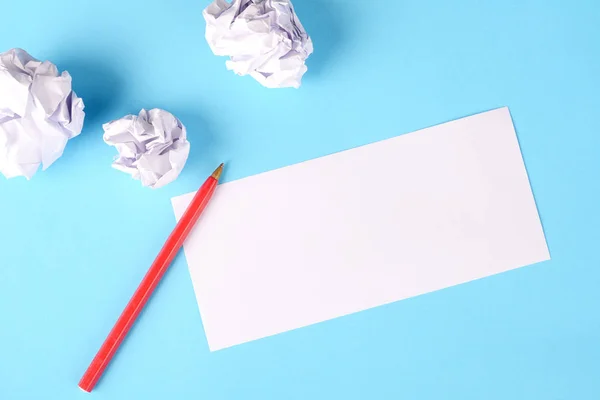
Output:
top-left (173, 108), bottom-right (550, 350)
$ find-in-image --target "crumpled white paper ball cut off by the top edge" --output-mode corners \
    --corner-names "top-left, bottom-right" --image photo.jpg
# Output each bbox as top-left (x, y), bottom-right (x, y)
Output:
top-left (203, 0), bottom-right (313, 88)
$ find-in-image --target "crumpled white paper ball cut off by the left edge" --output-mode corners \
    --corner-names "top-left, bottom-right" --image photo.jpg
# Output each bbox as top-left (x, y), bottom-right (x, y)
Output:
top-left (0, 49), bottom-right (85, 179)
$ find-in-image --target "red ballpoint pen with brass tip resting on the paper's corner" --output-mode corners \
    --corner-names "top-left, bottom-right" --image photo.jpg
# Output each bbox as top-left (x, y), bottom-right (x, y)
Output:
top-left (79, 164), bottom-right (223, 392)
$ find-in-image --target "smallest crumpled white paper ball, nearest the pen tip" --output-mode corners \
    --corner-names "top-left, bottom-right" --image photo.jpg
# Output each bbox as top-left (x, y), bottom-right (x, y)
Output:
top-left (102, 108), bottom-right (190, 189)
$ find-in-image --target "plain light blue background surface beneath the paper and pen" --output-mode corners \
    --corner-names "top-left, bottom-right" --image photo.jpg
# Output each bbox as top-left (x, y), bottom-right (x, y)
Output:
top-left (0, 0), bottom-right (600, 400)
